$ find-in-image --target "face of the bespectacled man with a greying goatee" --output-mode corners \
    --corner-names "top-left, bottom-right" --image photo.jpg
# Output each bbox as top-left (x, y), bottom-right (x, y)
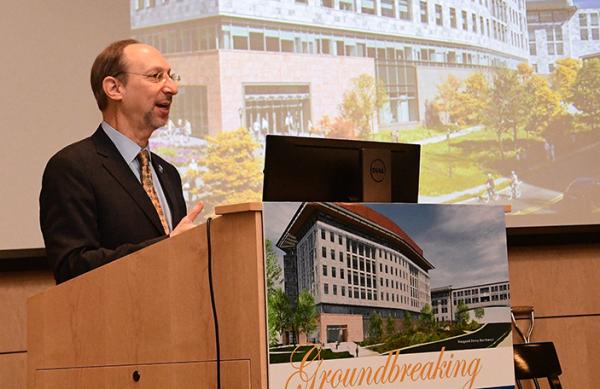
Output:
top-left (121, 44), bottom-right (177, 130)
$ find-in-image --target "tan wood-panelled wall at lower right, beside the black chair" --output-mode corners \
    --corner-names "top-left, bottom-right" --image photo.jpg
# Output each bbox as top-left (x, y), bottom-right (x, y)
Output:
top-left (509, 244), bottom-right (600, 388)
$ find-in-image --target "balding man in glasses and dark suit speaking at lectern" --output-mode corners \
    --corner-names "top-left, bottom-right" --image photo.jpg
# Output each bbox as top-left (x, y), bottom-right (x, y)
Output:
top-left (40, 39), bottom-right (203, 283)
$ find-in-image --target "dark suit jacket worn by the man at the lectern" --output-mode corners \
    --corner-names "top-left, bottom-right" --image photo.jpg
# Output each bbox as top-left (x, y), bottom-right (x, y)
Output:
top-left (40, 127), bottom-right (186, 283)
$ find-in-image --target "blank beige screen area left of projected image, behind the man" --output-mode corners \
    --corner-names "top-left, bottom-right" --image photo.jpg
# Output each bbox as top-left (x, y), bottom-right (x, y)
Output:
top-left (0, 0), bottom-right (130, 250)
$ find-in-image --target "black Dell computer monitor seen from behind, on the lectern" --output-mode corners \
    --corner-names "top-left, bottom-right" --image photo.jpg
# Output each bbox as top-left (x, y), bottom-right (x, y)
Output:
top-left (263, 135), bottom-right (421, 203)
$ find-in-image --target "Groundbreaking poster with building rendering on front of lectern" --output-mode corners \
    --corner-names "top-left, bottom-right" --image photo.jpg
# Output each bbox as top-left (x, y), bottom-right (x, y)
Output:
top-left (263, 203), bottom-right (514, 388)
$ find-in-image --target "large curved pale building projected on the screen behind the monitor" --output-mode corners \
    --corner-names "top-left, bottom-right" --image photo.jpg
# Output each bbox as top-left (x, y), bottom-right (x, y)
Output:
top-left (131, 0), bottom-right (529, 136)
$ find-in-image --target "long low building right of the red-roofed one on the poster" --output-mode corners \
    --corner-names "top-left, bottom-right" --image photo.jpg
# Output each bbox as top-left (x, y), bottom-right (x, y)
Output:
top-left (431, 281), bottom-right (510, 322)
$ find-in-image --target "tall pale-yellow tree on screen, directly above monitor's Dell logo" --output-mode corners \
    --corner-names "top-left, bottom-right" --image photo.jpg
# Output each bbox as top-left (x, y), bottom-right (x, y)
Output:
top-left (340, 73), bottom-right (388, 138)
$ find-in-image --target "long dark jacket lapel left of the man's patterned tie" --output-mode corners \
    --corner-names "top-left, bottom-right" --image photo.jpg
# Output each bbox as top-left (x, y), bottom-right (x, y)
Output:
top-left (92, 127), bottom-right (164, 234)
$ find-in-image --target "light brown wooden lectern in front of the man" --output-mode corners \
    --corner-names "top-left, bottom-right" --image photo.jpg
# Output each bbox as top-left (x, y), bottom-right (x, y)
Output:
top-left (27, 203), bottom-right (267, 389)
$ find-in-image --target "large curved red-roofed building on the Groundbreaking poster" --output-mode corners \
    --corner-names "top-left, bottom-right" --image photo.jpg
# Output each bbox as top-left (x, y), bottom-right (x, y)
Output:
top-left (277, 203), bottom-right (434, 343)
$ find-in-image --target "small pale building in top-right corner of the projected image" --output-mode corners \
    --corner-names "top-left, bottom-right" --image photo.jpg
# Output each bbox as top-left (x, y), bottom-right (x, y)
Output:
top-left (527, 0), bottom-right (600, 74)
